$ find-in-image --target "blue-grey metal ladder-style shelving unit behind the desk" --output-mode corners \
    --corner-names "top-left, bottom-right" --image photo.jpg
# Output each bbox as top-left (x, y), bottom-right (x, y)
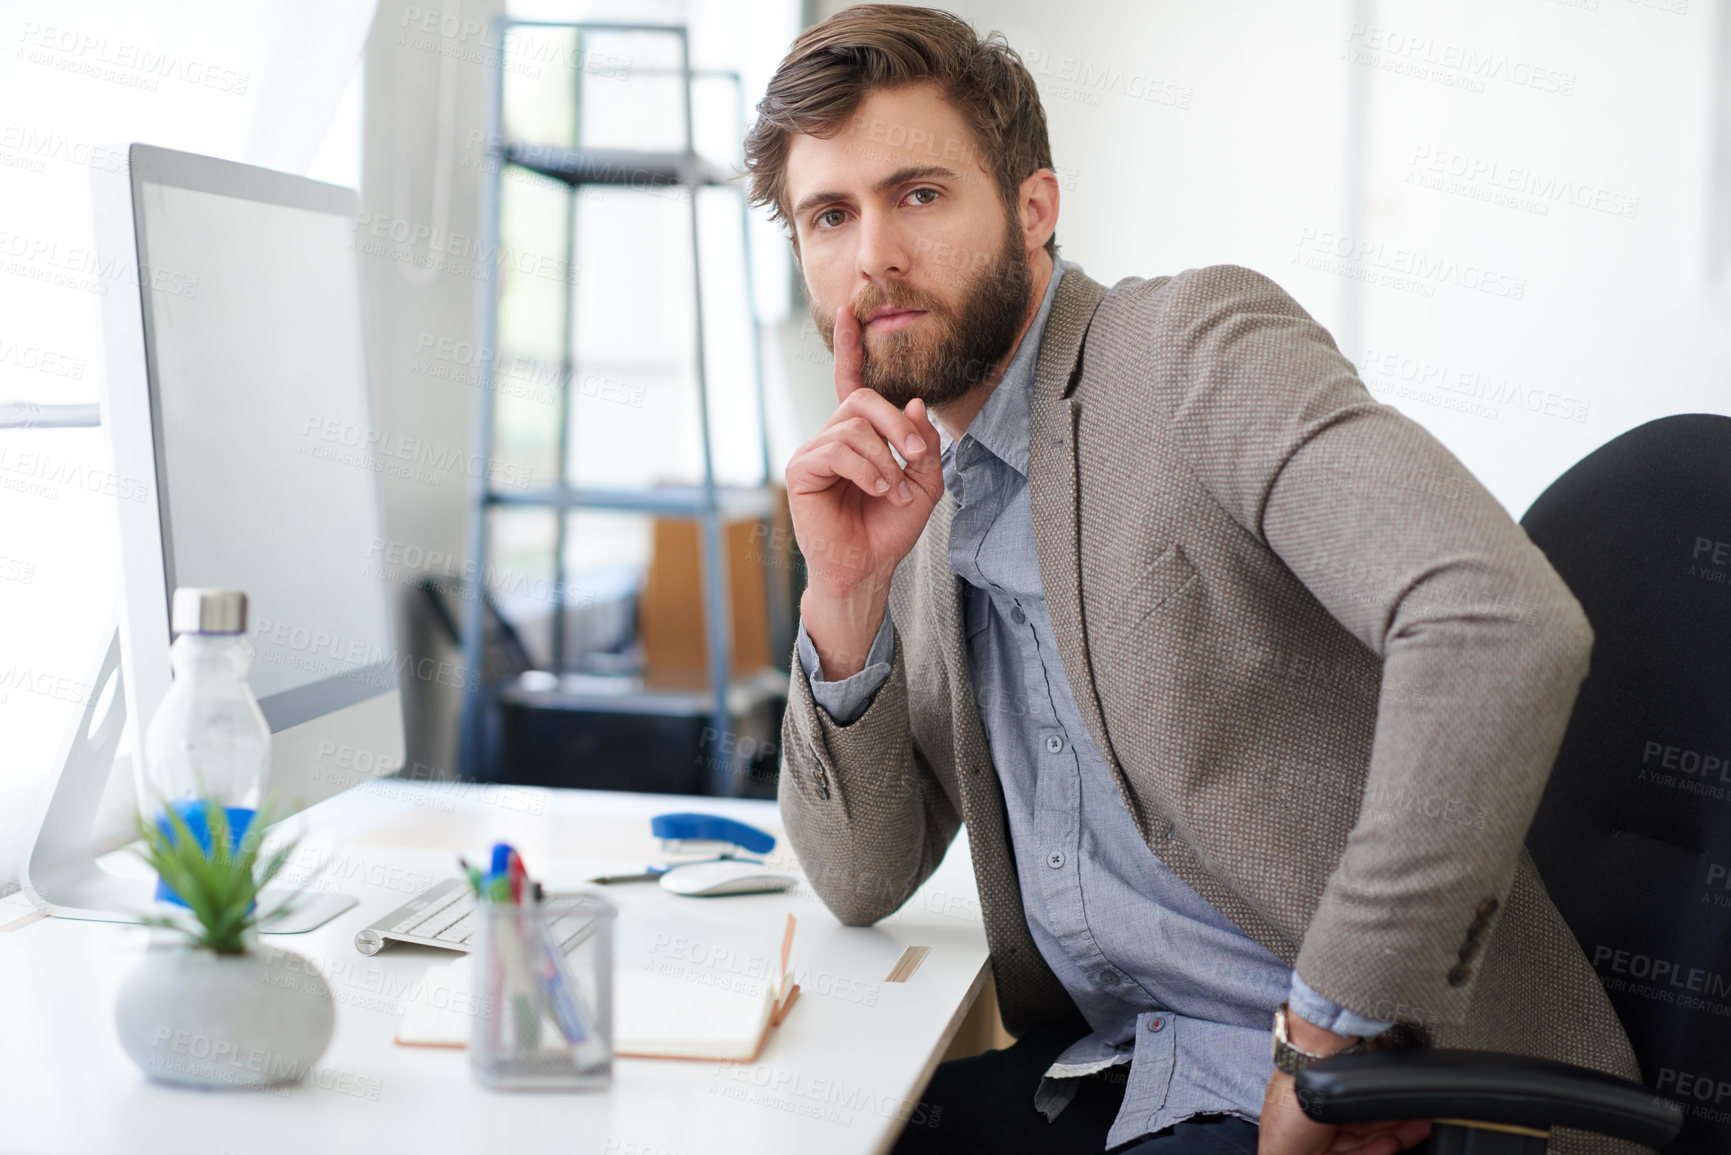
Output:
top-left (460, 19), bottom-right (793, 793)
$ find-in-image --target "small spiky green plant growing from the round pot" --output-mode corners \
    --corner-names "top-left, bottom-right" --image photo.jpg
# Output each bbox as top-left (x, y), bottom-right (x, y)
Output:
top-left (137, 798), bottom-right (299, 954)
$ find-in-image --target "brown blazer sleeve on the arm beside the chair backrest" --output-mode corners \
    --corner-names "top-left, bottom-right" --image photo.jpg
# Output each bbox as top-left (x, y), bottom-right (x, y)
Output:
top-left (1153, 267), bottom-right (1593, 1025)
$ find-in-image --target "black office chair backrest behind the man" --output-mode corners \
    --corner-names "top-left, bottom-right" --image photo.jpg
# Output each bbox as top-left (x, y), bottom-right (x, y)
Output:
top-left (1522, 414), bottom-right (1731, 1155)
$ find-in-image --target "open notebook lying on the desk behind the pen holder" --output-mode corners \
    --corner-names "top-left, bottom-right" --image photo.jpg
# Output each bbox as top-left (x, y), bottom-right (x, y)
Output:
top-left (396, 914), bottom-right (800, 1061)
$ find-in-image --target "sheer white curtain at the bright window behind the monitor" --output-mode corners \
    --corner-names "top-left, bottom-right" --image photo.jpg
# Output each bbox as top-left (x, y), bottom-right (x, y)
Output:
top-left (0, 0), bottom-right (376, 900)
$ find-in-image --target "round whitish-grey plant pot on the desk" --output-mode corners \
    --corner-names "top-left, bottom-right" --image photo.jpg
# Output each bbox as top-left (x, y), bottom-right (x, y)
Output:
top-left (114, 944), bottom-right (336, 1087)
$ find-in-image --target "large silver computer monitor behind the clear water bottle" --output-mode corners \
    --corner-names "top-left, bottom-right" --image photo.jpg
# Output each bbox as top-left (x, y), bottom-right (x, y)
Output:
top-left (20, 144), bottom-right (403, 921)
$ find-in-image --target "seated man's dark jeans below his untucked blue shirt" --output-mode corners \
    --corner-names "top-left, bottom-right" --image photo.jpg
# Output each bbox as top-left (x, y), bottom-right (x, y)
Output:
top-left (895, 1030), bottom-right (1257, 1155)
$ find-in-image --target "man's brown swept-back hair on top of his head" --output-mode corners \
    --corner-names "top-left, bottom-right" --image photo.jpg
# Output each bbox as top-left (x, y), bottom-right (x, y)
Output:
top-left (746, 3), bottom-right (1058, 255)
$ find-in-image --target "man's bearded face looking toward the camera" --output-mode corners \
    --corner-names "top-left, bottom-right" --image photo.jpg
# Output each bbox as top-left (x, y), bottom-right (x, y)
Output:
top-left (786, 85), bottom-right (1044, 407)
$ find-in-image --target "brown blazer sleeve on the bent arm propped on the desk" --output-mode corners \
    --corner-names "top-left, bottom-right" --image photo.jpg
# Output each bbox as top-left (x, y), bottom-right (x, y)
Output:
top-left (777, 612), bottom-right (961, 926)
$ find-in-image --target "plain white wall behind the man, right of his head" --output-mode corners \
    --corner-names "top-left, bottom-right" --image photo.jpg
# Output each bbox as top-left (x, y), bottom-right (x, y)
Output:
top-left (784, 0), bottom-right (1731, 516)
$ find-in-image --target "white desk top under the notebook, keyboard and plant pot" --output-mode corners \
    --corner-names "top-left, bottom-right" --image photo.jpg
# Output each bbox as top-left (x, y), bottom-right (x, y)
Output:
top-left (0, 781), bottom-right (987, 1155)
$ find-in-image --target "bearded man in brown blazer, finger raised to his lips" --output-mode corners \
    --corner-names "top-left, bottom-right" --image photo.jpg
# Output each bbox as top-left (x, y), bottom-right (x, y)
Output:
top-left (746, 5), bottom-right (1639, 1155)
